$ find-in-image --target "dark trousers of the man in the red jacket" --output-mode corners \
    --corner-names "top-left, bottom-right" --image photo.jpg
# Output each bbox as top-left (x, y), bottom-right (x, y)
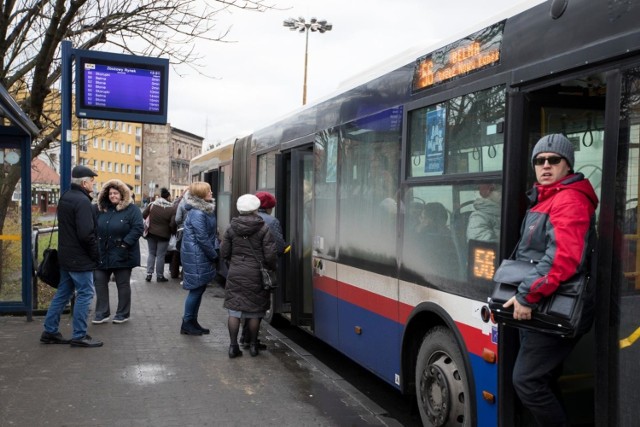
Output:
top-left (513, 329), bottom-right (580, 427)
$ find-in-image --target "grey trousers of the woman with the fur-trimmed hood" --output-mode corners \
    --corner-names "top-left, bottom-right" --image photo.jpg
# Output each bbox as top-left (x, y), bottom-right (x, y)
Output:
top-left (93, 268), bottom-right (131, 319)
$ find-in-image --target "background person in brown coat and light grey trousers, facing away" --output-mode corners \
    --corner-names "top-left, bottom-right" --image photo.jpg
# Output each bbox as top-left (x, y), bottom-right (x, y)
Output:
top-left (142, 187), bottom-right (176, 282)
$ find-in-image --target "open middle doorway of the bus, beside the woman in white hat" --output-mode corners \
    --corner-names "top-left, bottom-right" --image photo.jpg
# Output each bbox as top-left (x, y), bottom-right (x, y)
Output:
top-left (284, 145), bottom-right (314, 331)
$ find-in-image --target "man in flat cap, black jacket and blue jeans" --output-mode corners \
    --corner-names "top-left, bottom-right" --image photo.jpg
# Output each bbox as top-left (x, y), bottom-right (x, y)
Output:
top-left (40, 165), bottom-right (102, 347)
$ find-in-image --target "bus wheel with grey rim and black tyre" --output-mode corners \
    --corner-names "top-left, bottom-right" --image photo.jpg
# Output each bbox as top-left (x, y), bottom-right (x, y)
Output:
top-left (416, 327), bottom-right (471, 427)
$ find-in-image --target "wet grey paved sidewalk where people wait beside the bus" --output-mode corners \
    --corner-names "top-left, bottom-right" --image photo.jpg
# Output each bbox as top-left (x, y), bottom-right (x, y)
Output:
top-left (0, 254), bottom-right (399, 427)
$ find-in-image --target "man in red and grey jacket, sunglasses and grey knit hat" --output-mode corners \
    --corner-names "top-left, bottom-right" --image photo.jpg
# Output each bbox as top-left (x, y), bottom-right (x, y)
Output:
top-left (504, 134), bottom-right (598, 427)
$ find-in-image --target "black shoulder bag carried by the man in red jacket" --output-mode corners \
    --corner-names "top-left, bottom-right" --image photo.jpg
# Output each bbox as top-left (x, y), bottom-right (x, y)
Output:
top-left (489, 259), bottom-right (590, 338)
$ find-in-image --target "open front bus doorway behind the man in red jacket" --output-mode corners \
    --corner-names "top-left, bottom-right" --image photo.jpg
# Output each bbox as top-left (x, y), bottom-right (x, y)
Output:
top-left (500, 72), bottom-right (608, 425)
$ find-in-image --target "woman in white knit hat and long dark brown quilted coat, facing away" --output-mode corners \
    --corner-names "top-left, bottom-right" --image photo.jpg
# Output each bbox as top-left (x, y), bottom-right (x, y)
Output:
top-left (220, 194), bottom-right (277, 358)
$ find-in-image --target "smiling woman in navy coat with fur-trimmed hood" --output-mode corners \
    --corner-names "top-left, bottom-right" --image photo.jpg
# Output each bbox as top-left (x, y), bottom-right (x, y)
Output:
top-left (92, 179), bottom-right (144, 324)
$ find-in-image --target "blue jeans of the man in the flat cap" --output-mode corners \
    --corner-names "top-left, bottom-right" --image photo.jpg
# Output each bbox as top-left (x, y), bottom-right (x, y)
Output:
top-left (44, 268), bottom-right (95, 339)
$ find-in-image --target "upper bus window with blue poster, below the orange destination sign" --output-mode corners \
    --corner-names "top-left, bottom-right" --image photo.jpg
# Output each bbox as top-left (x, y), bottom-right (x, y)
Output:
top-left (407, 86), bottom-right (506, 177)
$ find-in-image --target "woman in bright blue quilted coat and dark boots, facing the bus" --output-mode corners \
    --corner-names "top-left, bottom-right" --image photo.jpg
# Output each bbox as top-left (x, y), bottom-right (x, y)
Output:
top-left (180, 181), bottom-right (218, 335)
